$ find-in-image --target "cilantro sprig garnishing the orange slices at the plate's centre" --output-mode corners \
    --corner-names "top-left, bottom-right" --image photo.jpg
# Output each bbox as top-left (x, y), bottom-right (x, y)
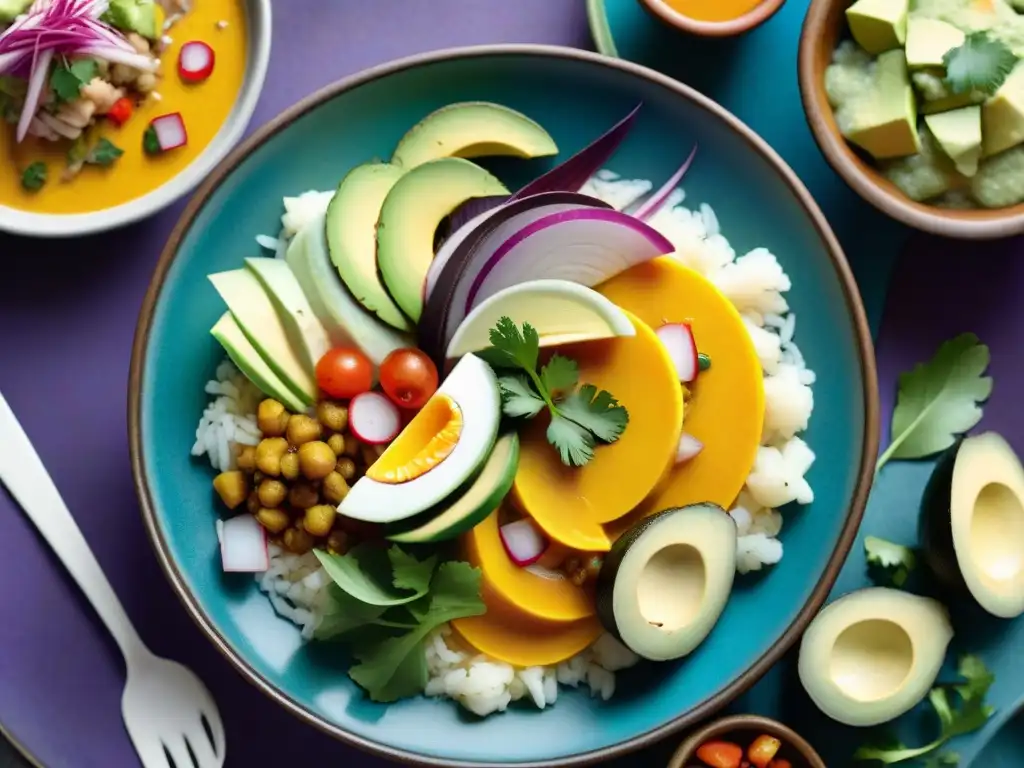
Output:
top-left (480, 316), bottom-right (630, 467)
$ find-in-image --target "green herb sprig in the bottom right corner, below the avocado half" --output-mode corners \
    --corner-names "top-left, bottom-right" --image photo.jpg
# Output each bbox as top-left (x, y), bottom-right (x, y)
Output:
top-left (853, 655), bottom-right (995, 768)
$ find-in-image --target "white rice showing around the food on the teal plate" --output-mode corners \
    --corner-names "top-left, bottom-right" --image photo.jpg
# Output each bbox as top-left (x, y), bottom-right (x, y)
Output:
top-left (191, 170), bottom-right (815, 717)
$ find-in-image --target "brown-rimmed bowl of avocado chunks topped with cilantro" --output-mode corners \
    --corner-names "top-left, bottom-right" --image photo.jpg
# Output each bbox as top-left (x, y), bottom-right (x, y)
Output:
top-left (799, 0), bottom-right (1024, 240)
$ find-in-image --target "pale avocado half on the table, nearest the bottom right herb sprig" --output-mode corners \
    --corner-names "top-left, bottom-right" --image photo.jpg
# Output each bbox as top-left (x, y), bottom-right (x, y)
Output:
top-left (798, 587), bottom-right (953, 727)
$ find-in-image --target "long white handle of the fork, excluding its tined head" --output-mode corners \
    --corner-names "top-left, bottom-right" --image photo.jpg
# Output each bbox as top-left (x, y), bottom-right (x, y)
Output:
top-left (0, 393), bottom-right (146, 667)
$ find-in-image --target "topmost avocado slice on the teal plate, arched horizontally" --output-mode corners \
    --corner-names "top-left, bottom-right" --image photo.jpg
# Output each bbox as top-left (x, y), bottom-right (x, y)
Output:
top-left (391, 101), bottom-right (558, 171)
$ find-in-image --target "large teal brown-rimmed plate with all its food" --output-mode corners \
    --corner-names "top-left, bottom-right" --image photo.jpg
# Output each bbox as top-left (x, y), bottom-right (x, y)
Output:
top-left (130, 46), bottom-right (877, 764)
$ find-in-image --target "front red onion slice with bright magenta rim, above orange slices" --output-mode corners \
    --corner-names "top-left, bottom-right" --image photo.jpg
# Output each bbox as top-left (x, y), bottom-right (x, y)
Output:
top-left (464, 208), bottom-right (676, 314)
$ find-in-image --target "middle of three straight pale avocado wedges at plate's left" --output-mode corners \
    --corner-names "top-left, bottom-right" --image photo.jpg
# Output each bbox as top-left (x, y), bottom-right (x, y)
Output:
top-left (208, 268), bottom-right (317, 410)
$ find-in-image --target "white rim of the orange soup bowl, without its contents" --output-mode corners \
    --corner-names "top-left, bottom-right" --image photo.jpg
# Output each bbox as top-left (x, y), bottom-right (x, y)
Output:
top-left (0, 0), bottom-right (271, 238)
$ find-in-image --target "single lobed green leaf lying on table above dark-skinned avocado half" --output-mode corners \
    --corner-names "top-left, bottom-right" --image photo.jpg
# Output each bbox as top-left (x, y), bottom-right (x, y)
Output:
top-left (874, 333), bottom-right (992, 473)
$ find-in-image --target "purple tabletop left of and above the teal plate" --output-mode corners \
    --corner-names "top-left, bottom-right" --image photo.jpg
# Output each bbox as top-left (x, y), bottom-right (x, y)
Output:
top-left (0, 0), bottom-right (590, 768)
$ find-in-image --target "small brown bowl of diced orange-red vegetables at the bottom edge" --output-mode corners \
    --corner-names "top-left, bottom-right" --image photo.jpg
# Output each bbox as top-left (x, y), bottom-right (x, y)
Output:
top-left (669, 715), bottom-right (825, 768)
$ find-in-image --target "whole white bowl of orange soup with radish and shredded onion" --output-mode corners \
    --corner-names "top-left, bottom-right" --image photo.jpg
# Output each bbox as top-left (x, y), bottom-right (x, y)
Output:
top-left (0, 0), bottom-right (270, 237)
